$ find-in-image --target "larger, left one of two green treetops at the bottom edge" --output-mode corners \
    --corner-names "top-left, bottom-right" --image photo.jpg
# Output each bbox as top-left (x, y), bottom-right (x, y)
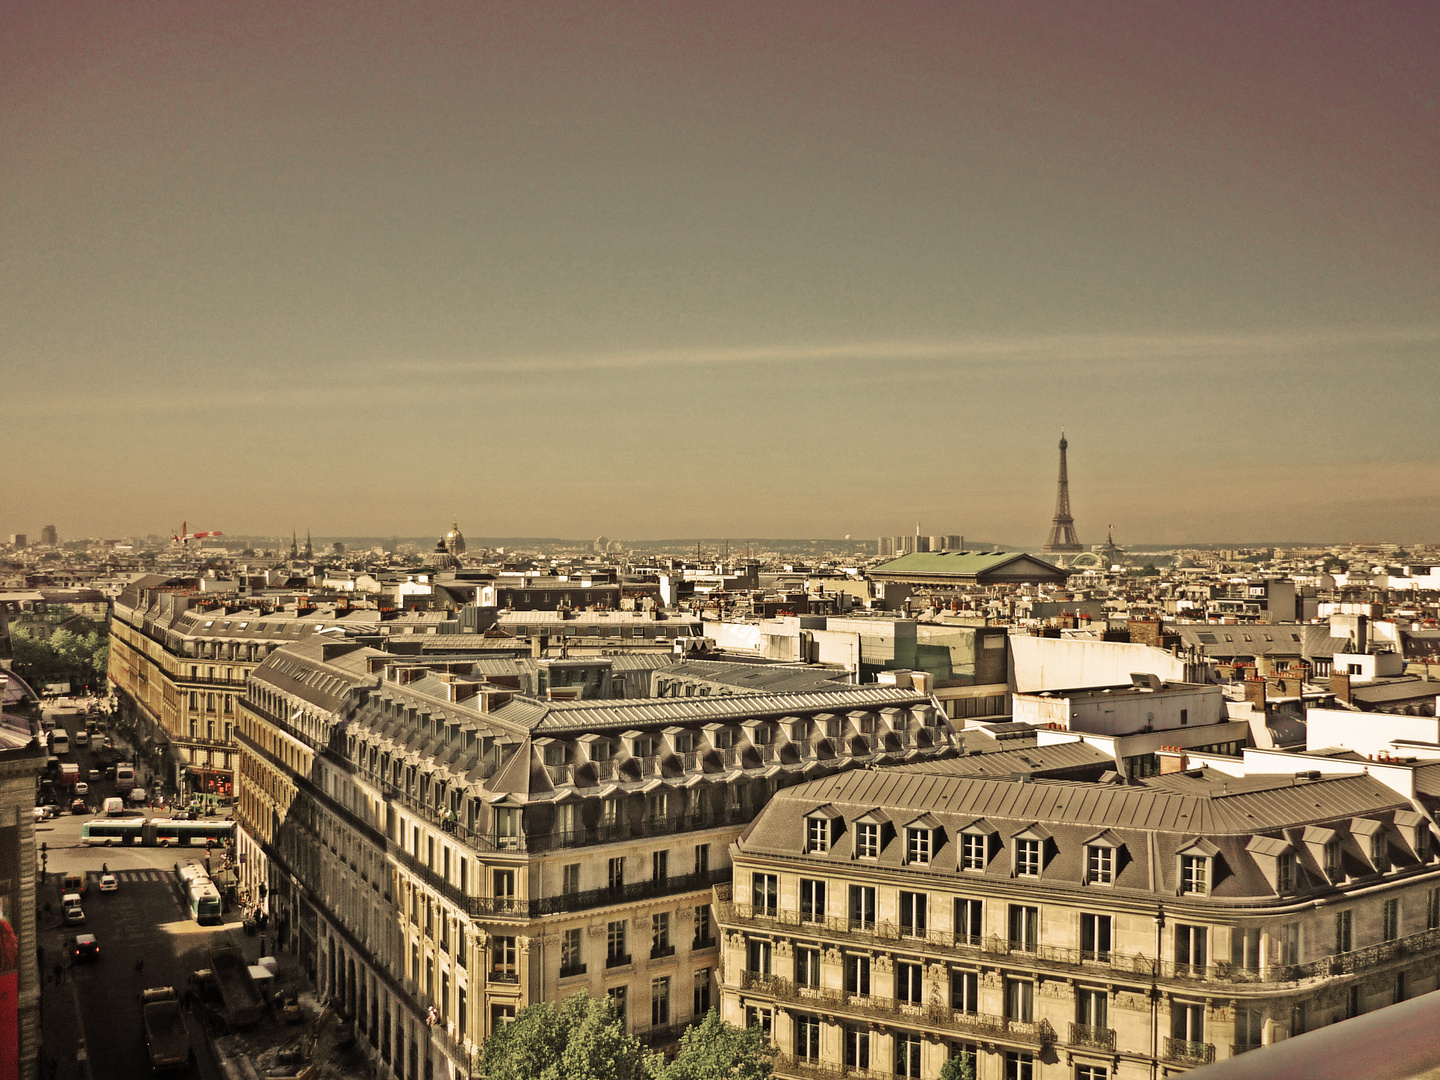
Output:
top-left (475, 994), bottom-right (660, 1080)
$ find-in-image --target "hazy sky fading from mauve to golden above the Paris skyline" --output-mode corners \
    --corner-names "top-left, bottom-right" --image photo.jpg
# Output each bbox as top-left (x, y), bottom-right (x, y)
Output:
top-left (0, 0), bottom-right (1440, 544)
